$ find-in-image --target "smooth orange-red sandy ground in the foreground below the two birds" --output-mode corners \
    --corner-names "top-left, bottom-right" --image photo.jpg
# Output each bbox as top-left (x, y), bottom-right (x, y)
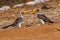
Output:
top-left (0, 23), bottom-right (60, 40)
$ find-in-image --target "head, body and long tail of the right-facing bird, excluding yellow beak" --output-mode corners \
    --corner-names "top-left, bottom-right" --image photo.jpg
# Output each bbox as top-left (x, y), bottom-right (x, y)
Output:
top-left (2, 12), bottom-right (23, 29)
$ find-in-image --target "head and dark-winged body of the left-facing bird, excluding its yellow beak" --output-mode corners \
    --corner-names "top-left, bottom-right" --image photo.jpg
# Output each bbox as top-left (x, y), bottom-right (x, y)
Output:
top-left (37, 9), bottom-right (54, 24)
